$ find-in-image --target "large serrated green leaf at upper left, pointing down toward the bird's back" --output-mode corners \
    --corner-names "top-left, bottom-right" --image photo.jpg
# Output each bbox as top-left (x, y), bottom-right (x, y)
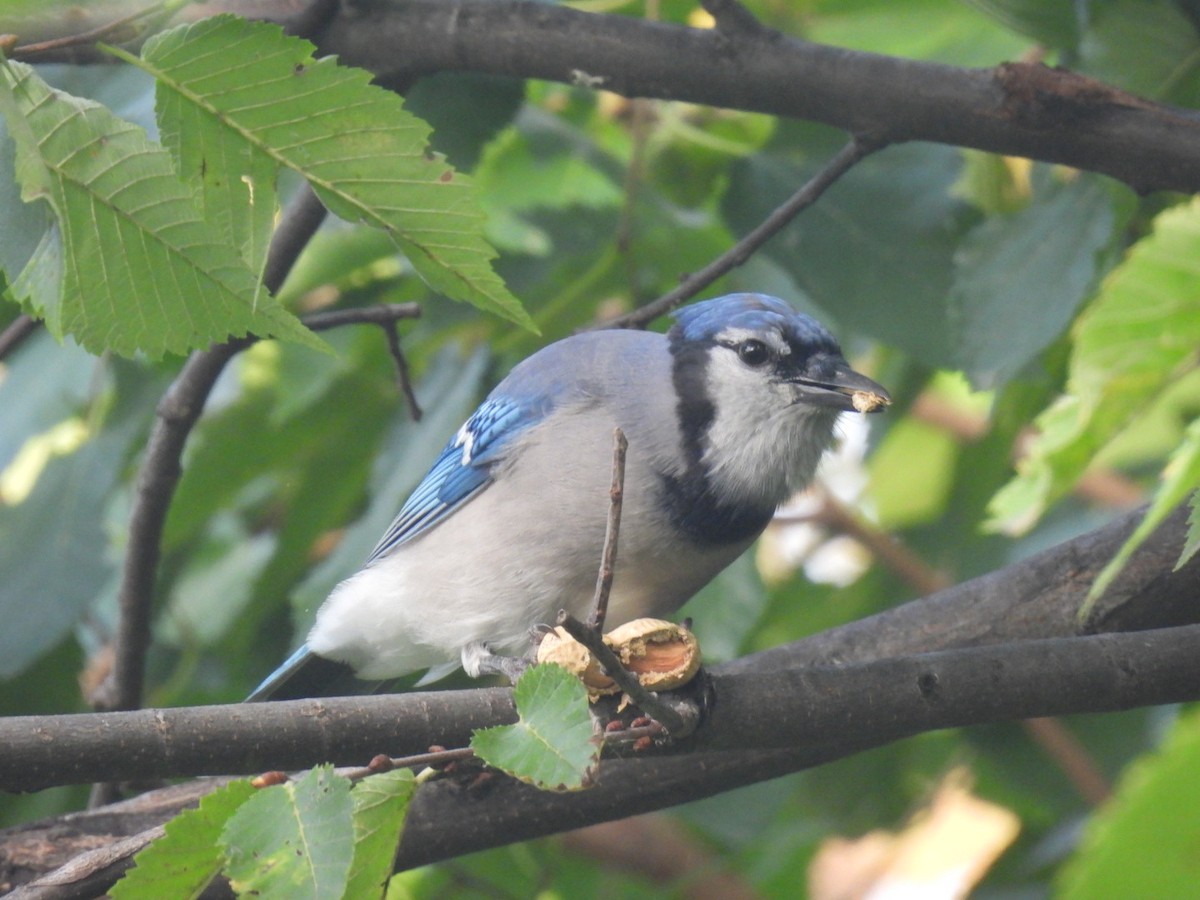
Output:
top-left (131, 16), bottom-right (535, 330)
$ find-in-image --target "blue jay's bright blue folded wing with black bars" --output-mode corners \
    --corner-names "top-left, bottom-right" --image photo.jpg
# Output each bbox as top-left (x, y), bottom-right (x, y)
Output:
top-left (366, 397), bottom-right (550, 565)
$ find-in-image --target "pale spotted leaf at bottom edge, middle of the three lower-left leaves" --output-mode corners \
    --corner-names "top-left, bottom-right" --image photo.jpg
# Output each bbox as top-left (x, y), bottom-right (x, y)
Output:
top-left (221, 766), bottom-right (354, 900)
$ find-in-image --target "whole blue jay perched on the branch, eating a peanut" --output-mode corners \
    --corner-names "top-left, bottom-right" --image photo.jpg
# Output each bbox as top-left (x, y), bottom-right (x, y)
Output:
top-left (250, 294), bottom-right (890, 700)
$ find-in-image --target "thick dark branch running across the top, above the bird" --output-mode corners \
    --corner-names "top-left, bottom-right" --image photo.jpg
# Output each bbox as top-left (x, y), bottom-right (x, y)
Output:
top-left (319, 0), bottom-right (1200, 192)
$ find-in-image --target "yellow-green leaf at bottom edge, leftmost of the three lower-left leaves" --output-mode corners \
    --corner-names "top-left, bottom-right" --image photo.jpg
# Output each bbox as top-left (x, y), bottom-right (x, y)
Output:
top-left (109, 780), bottom-right (256, 900)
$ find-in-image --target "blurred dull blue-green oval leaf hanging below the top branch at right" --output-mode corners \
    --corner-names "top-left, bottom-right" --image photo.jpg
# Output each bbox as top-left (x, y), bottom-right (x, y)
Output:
top-left (949, 175), bottom-right (1123, 389)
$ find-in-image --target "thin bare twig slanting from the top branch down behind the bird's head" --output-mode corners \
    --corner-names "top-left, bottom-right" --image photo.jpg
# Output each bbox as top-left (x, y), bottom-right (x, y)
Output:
top-left (596, 136), bottom-right (883, 328)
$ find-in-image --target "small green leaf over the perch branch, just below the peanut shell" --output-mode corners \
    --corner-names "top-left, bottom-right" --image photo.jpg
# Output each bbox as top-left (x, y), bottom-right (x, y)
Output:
top-left (470, 665), bottom-right (600, 791)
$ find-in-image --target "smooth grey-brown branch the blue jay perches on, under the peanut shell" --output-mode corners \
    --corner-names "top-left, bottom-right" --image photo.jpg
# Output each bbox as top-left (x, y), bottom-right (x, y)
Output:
top-left (0, 625), bottom-right (1200, 791)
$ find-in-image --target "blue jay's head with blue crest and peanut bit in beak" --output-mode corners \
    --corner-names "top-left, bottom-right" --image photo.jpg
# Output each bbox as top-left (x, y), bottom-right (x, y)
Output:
top-left (667, 294), bottom-right (892, 505)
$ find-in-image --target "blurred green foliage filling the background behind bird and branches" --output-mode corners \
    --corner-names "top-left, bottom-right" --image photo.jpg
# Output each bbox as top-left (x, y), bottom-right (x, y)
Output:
top-left (0, 0), bottom-right (1200, 898)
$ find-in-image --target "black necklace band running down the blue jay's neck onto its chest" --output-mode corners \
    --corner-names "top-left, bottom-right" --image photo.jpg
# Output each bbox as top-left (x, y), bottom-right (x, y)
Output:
top-left (659, 334), bottom-right (775, 545)
